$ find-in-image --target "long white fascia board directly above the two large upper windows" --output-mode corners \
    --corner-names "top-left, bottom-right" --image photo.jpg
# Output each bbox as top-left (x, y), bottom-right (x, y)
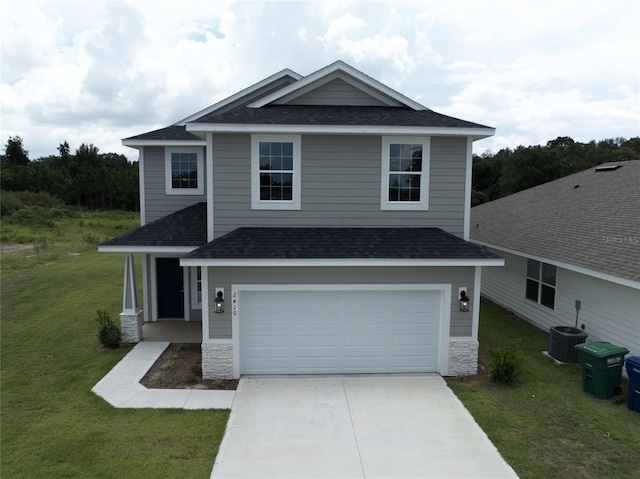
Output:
top-left (186, 123), bottom-right (496, 141)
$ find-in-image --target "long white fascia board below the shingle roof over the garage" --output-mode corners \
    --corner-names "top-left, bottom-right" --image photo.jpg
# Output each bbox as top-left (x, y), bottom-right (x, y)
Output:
top-left (180, 258), bottom-right (504, 268)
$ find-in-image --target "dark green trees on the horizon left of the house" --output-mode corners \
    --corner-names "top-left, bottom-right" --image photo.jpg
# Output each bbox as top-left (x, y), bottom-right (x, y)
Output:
top-left (0, 136), bottom-right (140, 211)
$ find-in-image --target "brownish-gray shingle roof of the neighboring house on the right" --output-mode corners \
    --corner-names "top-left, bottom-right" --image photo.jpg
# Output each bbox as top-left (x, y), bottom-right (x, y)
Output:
top-left (470, 161), bottom-right (640, 281)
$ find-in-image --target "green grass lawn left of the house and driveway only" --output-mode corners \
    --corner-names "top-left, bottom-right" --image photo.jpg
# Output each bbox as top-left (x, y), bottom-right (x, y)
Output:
top-left (0, 213), bottom-right (229, 478)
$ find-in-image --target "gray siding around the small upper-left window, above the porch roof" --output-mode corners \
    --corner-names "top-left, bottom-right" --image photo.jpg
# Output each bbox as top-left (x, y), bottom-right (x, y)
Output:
top-left (144, 146), bottom-right (207, 223)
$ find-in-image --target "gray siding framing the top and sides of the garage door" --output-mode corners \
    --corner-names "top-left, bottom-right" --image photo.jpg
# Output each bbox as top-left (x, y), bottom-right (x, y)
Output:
top-left (208, 267), bottom-right (475, 339)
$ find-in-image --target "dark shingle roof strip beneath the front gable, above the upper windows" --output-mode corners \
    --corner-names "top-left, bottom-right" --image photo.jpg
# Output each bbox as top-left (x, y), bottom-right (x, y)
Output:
top-left (194, 105), bottom-right (489, 128)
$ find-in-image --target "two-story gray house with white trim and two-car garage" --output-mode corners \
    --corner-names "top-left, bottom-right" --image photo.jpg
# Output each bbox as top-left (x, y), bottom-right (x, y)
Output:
top-left (99, 62), bottom-right (504, 378)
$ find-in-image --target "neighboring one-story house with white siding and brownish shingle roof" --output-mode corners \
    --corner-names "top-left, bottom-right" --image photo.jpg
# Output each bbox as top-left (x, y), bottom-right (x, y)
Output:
top-left (471, 161), bottom-right (640, 355)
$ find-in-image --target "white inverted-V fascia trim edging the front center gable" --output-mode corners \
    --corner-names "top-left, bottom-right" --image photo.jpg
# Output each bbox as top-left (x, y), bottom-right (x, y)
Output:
top-left (248, 60), bottom-right (428, 110)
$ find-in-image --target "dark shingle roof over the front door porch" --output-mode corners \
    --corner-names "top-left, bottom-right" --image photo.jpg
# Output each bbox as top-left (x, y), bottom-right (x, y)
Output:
top-left (100, 203), bottom-right (207, 247)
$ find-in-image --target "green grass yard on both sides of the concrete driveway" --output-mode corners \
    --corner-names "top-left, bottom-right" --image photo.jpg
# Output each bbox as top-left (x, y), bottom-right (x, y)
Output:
top-left (0, 212), bottom-right (640, 479)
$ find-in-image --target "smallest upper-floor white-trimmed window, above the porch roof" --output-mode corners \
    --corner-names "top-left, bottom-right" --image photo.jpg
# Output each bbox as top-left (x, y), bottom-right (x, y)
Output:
top-left (165, 147), bottom-right (204, 195)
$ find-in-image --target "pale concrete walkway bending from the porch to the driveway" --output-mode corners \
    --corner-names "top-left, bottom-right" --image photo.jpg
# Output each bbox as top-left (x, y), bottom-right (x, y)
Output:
top-left (91, 341), bottom-right (235, 409)
